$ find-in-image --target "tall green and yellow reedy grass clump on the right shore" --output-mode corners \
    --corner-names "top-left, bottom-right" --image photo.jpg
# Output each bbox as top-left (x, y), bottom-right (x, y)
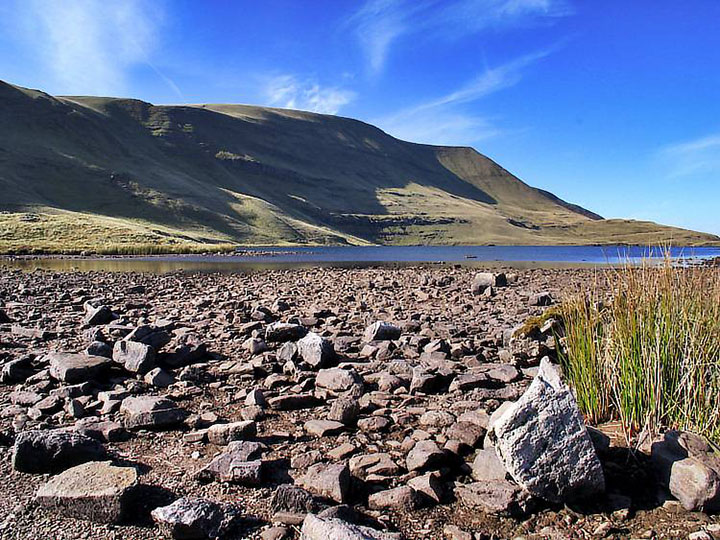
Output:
top-left (561, 260), bottom-right (720, 441)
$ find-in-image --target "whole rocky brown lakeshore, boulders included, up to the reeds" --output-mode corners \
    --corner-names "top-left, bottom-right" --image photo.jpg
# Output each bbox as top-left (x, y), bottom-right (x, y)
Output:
top-left (0, 265), bottom-right (720, 540)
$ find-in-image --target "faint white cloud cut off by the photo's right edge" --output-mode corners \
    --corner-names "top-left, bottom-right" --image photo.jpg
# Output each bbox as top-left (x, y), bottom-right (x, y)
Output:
top-left (659, 133), bottom-right (720, 178)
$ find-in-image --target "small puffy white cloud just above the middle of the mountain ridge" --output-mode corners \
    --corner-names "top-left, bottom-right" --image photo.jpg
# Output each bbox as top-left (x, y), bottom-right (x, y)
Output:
top-left (263, 75), bottom-right (355, 114)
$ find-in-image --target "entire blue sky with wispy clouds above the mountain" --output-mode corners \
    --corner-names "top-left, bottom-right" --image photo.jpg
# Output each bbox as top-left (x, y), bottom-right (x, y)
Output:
top-left (0, 0), bottom-right (720, 234)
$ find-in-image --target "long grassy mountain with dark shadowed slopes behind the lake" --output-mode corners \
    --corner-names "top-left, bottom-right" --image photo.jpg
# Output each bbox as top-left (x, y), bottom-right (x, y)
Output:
top-left (0, 82), bottom-right (720, 252)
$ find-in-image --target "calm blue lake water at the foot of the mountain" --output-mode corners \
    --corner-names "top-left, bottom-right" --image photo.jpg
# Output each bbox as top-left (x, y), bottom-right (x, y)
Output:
top-left (0, 246), bottom-right (720, 272)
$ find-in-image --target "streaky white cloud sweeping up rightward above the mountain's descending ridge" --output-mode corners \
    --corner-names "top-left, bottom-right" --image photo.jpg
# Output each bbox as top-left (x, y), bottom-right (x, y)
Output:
top-left (374, 49), bottom-right (552, 145)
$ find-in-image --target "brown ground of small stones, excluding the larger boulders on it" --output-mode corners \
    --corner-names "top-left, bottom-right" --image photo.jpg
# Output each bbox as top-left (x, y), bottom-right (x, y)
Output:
top-left (0, 265), bottom-right (720, 539)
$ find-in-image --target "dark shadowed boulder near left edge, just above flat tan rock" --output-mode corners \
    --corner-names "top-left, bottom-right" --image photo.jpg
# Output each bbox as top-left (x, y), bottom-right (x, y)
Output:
top-left (12, 429), bottom-right (106, 473)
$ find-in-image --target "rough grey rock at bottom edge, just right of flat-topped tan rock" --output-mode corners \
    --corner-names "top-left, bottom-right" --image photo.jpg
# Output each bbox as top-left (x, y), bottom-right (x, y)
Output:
top-left (150, 497), bottom-right (240, 540)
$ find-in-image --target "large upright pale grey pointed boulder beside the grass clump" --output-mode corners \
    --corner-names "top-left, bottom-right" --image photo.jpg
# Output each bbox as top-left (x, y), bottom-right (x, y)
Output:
top-left (490, 359), bottom-right (605, 502)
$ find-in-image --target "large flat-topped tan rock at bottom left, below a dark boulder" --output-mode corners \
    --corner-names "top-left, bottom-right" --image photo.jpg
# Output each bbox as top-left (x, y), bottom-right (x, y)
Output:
top-left (36, 461), bottom-right (138, 523)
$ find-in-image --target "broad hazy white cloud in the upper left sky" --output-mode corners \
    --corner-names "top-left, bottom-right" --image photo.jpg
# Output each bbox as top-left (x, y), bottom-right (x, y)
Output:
top-left (12, 0), bottom-right (182, 97)
